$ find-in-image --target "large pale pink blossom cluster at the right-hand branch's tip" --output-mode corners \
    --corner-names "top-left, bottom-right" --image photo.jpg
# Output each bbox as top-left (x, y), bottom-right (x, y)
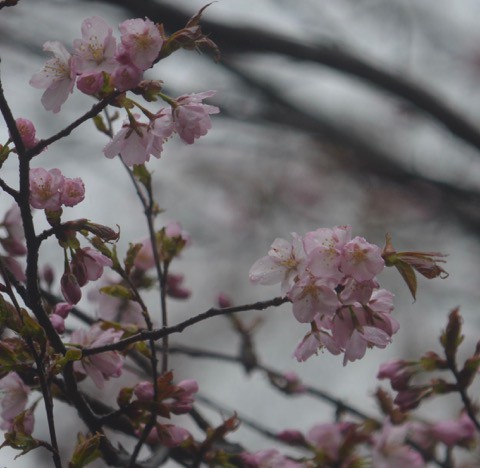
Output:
top-left (250, 226), bottom-right (399, 365)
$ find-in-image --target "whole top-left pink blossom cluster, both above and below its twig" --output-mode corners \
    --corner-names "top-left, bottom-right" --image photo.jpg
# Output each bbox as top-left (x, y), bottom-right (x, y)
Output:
top-left (30, 16), bottom-right (219, 166)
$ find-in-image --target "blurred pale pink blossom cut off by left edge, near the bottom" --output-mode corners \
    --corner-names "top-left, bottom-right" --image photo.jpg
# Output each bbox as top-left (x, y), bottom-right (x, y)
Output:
top-left (0, 372), bottom-right (30, 429)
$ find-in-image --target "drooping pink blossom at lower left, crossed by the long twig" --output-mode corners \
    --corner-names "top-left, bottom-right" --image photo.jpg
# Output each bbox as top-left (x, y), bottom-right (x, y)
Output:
top-left (71, 325), bottom-right (123, 388)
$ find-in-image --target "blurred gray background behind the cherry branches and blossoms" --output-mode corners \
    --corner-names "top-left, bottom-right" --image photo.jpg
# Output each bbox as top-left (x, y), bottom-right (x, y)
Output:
top-left (0, 0), bottom-right (480, 467)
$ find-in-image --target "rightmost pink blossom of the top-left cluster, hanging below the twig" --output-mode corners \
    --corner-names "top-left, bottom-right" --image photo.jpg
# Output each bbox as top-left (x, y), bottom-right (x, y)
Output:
top-left (173, 91), bottom-right (220, 144)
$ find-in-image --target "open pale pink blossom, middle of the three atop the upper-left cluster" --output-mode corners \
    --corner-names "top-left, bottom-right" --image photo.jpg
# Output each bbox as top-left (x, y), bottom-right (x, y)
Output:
top-left (73, 16), bottom-right (116, 74)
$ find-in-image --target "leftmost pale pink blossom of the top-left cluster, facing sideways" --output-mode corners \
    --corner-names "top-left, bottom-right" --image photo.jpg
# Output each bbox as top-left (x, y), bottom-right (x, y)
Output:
top-left (30, 41), bottom-right (76, 113)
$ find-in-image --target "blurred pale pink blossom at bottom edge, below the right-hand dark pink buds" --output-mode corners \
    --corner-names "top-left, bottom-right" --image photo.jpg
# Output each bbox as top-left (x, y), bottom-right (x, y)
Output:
top-left (372, 421), bottom-right (425, 468)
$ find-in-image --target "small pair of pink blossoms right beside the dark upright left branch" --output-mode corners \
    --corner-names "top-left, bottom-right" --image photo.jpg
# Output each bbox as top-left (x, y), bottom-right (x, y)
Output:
top-left (30, 167), bottom-right (85, 211)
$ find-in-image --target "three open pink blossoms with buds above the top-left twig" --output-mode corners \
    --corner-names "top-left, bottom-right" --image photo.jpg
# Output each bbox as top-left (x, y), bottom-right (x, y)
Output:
top-left (30, 16), bottom-right (163, 112)
